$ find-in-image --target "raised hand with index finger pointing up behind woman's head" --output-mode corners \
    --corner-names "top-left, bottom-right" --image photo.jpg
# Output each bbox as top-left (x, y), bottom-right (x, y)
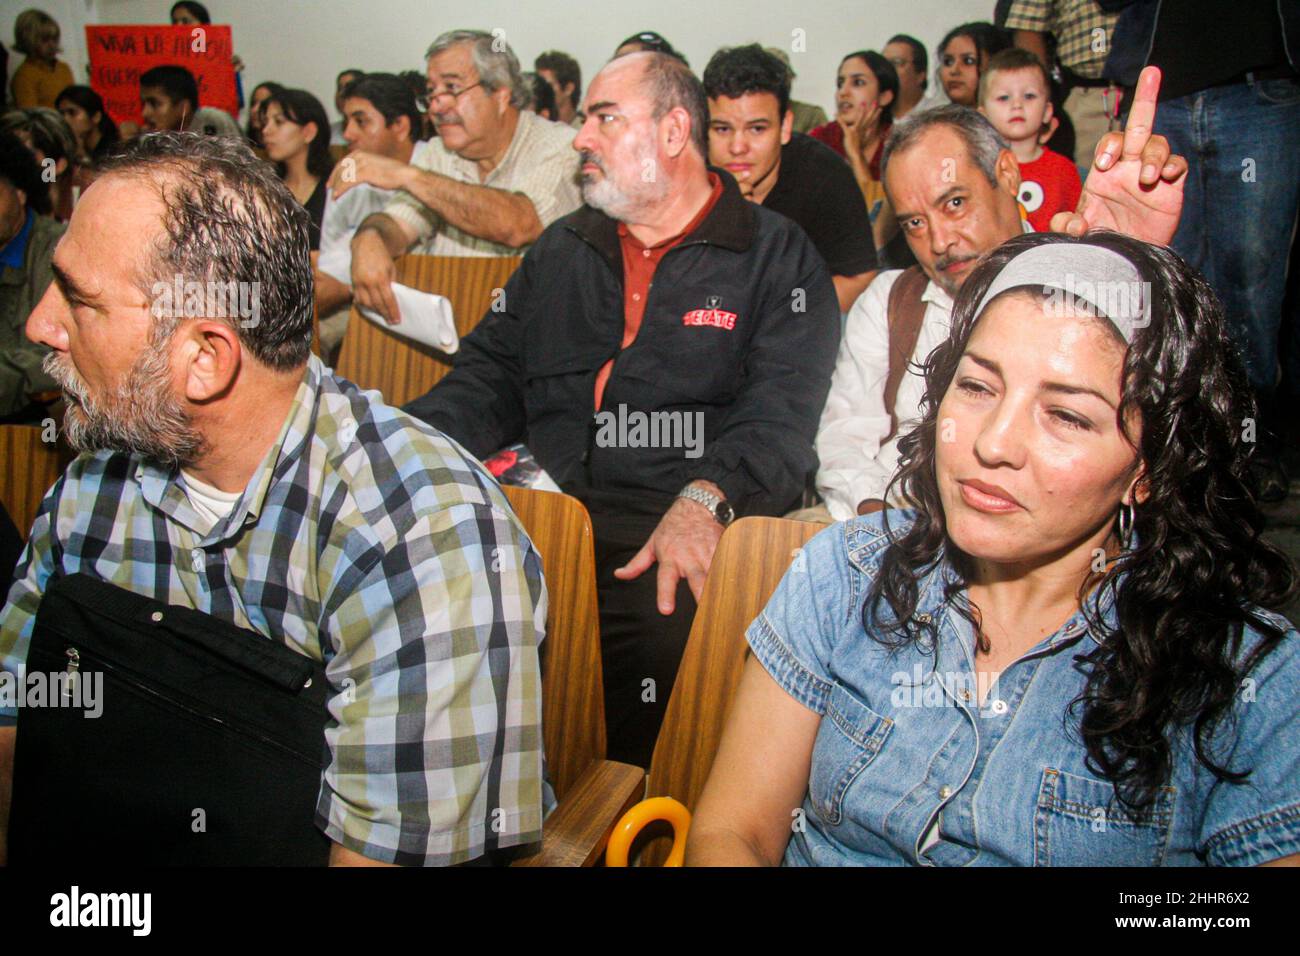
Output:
top-left (1052, 66), bottom-right (1187, 246)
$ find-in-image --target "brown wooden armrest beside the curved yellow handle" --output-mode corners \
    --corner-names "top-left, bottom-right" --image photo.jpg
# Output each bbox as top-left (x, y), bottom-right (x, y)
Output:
top-left (511, 760), bottom-right (646, 866)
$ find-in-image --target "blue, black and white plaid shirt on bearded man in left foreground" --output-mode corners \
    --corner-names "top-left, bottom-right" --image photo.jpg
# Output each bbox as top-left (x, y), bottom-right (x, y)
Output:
top-left (0, 356), bottom-right (546, 865)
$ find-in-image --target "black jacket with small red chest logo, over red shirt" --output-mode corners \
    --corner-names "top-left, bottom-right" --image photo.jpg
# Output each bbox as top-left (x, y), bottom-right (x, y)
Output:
top-left (407, 173), bottom-right (840, 514)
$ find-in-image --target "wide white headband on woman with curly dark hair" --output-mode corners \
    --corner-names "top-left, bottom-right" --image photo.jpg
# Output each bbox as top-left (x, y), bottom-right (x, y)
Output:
top-left (975, 242), bottom-right (1151, 342)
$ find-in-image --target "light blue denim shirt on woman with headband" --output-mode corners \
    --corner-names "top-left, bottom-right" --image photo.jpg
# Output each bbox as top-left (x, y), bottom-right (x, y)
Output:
top-left (746, 511), bottom-right (1300, 866)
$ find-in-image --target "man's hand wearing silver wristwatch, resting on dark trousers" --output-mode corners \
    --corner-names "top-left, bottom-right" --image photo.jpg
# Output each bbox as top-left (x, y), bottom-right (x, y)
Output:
top-left (614, 481), bottom-right (725, 615)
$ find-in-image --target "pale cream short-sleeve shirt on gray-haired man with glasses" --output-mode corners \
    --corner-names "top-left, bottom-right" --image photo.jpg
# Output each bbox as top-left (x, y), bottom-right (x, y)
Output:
top-left (384, 109), bottom-right (582, 256)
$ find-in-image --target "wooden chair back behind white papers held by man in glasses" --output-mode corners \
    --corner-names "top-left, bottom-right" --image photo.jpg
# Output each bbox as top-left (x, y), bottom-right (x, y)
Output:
top-left (338, 255), bottom-right (521, 406)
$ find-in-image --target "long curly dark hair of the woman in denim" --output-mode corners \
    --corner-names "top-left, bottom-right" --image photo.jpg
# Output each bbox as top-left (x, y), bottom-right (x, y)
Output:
top-left (863, 233), bottom-right (1296, 810)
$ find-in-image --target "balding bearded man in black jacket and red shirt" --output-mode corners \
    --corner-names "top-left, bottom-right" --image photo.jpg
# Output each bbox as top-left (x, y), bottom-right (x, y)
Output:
top-left (408, 53), bottom-right (840, 766)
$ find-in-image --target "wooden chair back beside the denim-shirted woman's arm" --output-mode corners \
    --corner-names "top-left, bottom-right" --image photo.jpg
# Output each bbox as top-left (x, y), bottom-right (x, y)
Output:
top-left (641, 518), bottom-right (824, 866)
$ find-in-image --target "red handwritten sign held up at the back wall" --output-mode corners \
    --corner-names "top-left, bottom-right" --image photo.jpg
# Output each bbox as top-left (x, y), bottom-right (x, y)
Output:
top-left (86, 23), bottom-right (239, 124)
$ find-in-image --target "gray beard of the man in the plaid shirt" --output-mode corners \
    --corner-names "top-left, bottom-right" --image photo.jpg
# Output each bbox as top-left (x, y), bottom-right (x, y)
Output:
top-left (44, 336), bottom-right (204, 468)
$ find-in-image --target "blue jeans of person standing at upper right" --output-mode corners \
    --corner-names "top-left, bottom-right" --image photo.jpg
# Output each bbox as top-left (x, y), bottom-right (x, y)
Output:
top-left (1156, 79), bottom-right (1300, 397)
